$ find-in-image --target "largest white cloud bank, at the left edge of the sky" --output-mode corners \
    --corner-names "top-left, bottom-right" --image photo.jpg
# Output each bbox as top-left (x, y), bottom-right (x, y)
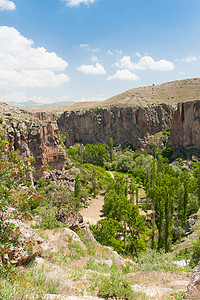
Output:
top-left (0, 26), bottom-right (70, 88)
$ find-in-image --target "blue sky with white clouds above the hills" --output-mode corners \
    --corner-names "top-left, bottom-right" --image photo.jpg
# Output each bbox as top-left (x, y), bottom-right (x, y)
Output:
top-left (0, 0), bottom-right (200, 104)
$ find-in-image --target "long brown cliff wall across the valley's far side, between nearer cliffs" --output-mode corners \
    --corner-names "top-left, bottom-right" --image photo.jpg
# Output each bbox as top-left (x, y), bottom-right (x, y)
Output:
top-left (58, 104), bottom-right (173, 148)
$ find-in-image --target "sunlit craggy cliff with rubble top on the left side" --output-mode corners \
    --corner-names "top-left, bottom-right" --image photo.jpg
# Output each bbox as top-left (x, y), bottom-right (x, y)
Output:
top-left (0, 103), bottom-right (66, 180)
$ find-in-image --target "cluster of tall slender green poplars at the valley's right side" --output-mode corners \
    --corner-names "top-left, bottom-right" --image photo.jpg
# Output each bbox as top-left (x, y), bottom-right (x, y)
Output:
top-left (145, 155), bottom-right (199, 252)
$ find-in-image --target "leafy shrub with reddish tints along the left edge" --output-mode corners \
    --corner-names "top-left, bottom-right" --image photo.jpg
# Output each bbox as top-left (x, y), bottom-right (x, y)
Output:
top-left (0, 131), bottom-right (32, 255)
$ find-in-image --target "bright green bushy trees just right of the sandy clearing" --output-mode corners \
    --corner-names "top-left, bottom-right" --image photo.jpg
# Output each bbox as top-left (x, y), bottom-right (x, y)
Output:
top-left (90, 176), bottom-right (146, 255)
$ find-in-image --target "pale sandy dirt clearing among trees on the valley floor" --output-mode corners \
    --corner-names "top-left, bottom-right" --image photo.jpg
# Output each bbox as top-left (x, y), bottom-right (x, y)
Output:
top-left (80, 194), bottom-right (104, 224)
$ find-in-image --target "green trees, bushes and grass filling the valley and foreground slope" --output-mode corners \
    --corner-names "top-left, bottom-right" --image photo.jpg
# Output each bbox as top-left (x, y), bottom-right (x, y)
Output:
top-left (0, 130), bottom-right (200, 299)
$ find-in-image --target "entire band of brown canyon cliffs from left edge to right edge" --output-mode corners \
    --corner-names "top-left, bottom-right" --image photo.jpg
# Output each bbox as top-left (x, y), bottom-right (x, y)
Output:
top-left (0, 100), bottom-right (200, 180)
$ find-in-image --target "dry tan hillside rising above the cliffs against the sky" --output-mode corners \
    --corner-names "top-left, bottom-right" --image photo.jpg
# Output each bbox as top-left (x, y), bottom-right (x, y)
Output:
top-left (26, 78), bottom-right (200, 113)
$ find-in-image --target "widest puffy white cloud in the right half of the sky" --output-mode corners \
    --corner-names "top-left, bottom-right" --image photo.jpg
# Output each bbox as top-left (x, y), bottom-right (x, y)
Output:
top-left (115, 56), bottom-right (174, 71)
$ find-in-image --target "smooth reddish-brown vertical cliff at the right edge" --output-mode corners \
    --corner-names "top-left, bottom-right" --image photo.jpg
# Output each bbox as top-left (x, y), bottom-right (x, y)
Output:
top-left (169, 100), bottom-right (200, 153)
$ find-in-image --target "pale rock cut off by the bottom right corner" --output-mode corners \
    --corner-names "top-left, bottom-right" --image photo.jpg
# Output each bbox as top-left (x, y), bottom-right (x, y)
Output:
top-left (186, 262), bottom-right (200, 300)
